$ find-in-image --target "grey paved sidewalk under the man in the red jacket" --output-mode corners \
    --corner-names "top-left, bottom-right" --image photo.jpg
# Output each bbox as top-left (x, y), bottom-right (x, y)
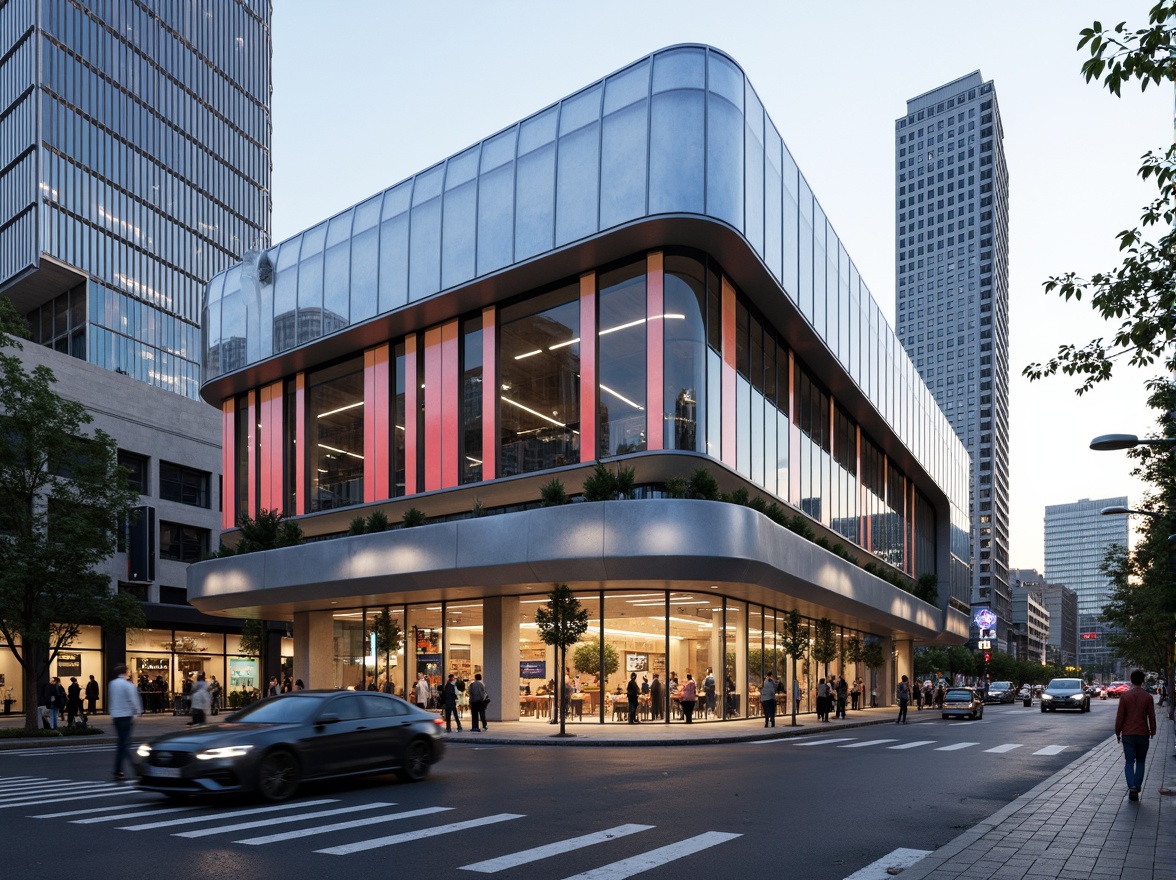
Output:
top-left (902, 707), bottom-right (1176, 880)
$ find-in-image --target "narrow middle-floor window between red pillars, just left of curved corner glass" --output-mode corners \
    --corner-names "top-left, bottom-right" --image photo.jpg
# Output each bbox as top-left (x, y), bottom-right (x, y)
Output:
top-left (596, 260), bottom-right (647, 458)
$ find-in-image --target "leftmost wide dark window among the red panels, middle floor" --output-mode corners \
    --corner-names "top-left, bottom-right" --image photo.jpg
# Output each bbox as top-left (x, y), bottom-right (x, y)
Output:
top-left (306, 358), bottom-right (363, 511)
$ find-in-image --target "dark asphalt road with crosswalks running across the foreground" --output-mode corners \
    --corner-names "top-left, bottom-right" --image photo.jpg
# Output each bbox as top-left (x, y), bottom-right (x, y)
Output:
top-left (0, 701), bottom-right (1115, 880)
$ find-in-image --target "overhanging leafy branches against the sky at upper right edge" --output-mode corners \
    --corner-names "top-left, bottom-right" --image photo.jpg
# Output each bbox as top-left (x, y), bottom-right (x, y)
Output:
top-left (1022, 0), bottom-right (1176, 394)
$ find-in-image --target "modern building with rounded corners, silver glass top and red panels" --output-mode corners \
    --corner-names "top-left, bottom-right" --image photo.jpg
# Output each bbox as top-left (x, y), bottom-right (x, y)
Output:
top-left (188, 46), bottom-right (969, 720)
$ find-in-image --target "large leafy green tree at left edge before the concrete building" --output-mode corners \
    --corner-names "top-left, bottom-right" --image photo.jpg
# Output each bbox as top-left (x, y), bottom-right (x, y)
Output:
top-left (0, 299), bottom-right (146, 729)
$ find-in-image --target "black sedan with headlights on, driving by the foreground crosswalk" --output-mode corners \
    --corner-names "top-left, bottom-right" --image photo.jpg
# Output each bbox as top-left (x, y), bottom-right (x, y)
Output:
top-left (134, 691), bottom-right (445, 801)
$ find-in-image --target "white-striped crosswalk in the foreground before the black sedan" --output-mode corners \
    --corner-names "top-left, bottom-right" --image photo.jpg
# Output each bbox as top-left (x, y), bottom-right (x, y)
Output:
top-left (0, 775), bottom-right (742, 880)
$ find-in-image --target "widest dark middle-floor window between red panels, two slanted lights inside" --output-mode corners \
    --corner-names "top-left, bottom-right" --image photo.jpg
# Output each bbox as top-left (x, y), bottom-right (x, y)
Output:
top-left (499, 285), bottom-right (580, 476)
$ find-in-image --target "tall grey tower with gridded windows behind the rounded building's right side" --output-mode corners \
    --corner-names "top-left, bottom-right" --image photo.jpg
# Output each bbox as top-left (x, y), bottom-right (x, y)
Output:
top-left (895, 71), bottom-right (1013, 649)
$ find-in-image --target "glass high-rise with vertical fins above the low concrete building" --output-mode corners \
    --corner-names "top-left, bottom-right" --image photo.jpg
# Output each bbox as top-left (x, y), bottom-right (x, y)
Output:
top-left (0, 0), bottom-right (270, 399)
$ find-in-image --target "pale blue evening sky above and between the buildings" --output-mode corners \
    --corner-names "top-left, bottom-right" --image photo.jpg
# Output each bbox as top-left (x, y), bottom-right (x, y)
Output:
top-left (273, 0), bottom-right (1172, 569)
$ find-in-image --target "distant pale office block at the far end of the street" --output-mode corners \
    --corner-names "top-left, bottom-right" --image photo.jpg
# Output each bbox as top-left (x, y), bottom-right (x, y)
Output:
top-left (1045, 495), bottom-right (1129, 675)
